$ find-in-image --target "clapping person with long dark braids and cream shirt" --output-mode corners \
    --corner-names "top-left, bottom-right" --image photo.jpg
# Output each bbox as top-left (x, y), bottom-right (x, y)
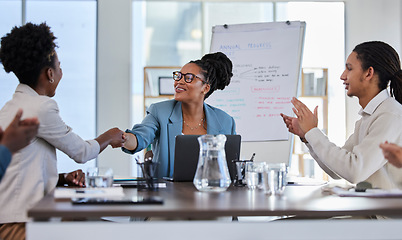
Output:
top-left (282, 41), bottom-right (402, 189)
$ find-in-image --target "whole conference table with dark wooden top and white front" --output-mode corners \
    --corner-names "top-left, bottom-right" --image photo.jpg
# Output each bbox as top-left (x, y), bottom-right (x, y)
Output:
top-left (27, 182), bottom-right (402, 239)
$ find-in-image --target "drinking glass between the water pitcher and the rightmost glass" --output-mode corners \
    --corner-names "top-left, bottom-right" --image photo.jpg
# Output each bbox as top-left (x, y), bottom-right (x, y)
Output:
top-left (246, 162), bottom-right (266, 190)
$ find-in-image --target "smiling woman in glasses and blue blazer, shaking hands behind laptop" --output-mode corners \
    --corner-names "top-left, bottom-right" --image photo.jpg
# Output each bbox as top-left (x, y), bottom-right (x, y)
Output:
top-left (123, 52), bottom-right (236, 178)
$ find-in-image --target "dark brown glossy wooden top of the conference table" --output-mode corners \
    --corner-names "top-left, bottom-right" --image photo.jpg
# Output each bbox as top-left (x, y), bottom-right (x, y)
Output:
top-left (28, 182), bottom-right (402, 220)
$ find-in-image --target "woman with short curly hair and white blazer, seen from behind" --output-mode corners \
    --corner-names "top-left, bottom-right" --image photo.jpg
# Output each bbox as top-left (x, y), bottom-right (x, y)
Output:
top-left (0, 23), bottom-right (124, 239)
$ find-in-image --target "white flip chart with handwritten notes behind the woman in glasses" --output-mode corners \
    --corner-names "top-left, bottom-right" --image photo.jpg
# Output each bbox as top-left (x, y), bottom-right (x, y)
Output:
top-left (206, 21), bottom-right (306, 162)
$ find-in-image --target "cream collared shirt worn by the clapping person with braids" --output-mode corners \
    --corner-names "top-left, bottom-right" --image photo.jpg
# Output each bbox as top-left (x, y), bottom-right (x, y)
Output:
top-left (305, 90), bottom-right (402, 189)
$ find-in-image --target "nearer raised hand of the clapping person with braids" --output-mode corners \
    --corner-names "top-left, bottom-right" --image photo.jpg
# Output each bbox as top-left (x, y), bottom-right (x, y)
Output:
top-left (291, 98), bottom-right (318, 135)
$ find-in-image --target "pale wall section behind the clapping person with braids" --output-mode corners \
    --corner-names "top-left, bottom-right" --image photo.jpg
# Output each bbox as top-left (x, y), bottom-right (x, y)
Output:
top-left (345, 0), bottom-right (402, 136)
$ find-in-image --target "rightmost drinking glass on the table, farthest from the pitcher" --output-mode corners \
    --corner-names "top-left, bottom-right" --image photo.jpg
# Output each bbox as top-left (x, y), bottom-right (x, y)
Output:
top-left (264, 163), bottom-right (287, 195)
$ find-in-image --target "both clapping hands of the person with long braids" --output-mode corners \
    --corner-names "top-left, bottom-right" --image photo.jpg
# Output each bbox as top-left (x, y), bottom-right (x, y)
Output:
top-left (281, 98), bottom-right (318, 138)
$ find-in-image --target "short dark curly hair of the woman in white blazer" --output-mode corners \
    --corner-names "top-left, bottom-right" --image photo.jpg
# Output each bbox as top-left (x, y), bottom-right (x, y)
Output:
top-left (0, 23), bottom-right (57, 88)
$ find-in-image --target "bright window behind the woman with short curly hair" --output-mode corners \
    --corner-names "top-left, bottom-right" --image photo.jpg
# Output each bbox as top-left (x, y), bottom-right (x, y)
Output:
top-left (0, 0), bottom-right (97, 172)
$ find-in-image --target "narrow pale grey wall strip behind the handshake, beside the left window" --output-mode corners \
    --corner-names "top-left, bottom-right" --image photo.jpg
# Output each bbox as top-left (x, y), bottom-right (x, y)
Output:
top-left (97, 0), bottom-right (132, 176)
